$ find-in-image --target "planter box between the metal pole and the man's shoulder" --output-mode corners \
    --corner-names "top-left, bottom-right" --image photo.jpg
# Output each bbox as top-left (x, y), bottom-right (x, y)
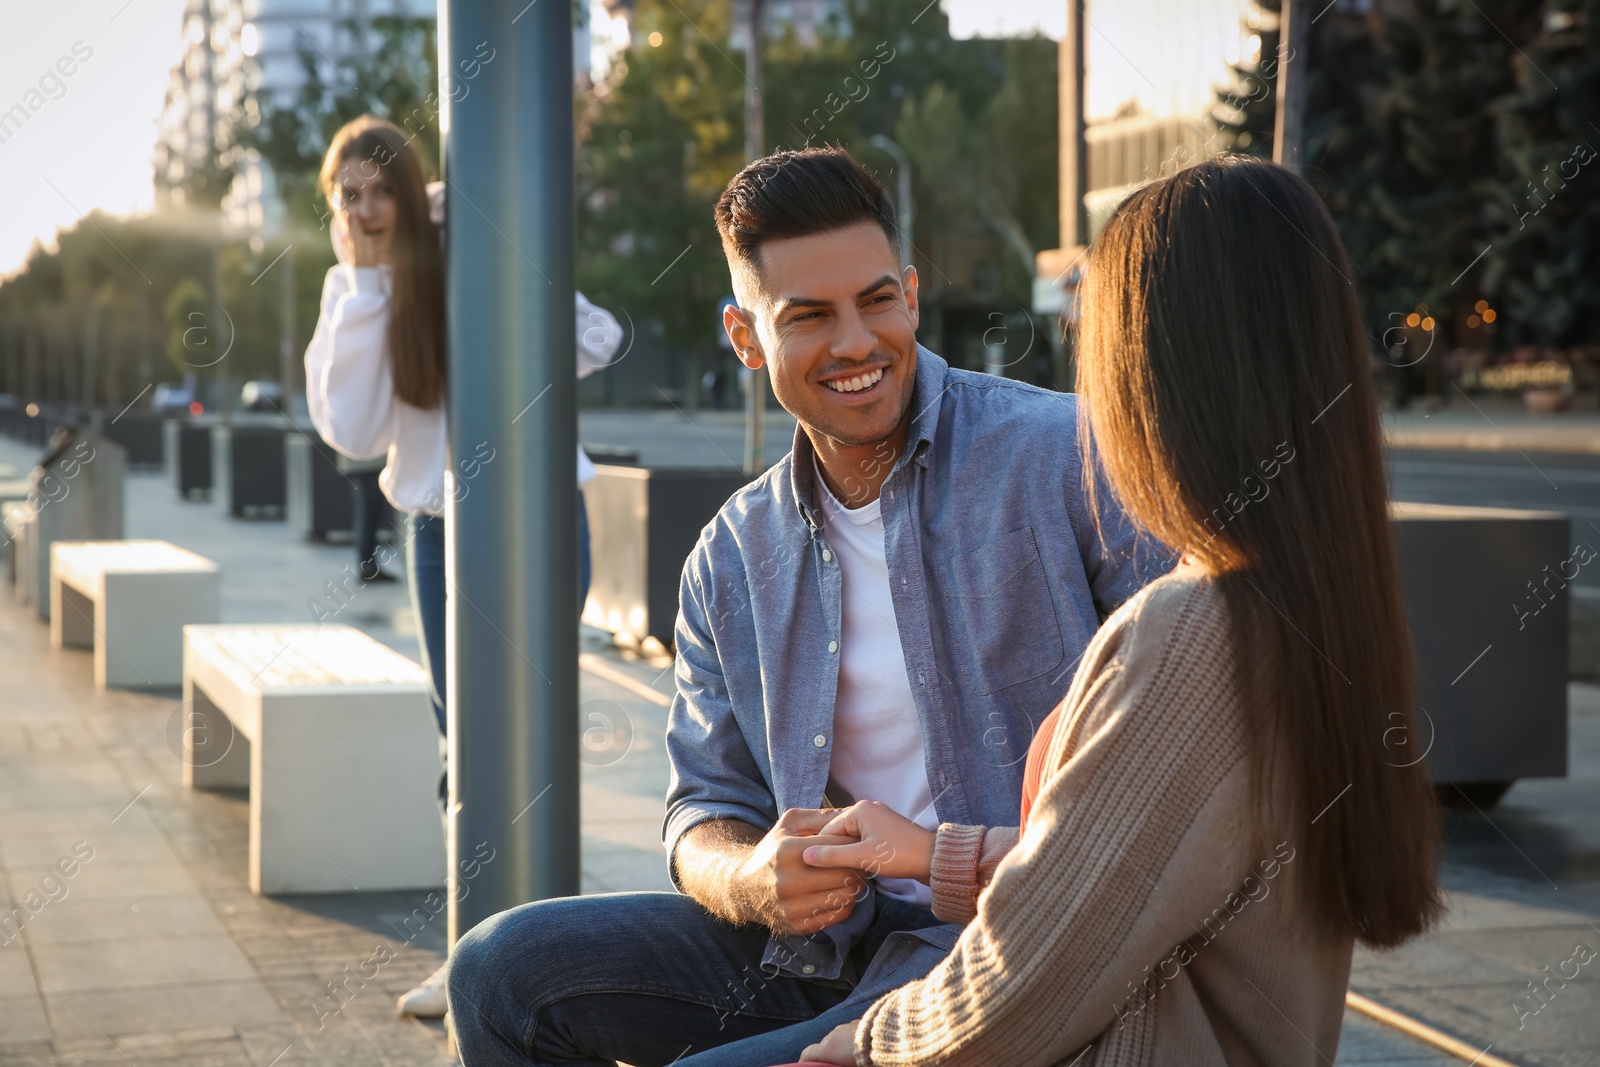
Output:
top-left (584, 464), bottom-right (746, 649)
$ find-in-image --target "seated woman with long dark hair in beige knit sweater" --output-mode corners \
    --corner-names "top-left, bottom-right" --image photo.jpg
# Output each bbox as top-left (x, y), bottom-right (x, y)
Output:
top-left (780, 158), bottom-right (1440, 1067)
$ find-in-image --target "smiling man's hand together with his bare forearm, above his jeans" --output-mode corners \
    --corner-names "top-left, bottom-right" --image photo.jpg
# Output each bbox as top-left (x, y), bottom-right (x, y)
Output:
top-left (674, 808), bottom-right (866, 936)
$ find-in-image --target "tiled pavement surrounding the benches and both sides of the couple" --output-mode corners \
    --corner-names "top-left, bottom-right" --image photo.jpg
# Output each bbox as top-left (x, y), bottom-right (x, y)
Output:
top-left (0, 442), bottom-right (1600, 1067)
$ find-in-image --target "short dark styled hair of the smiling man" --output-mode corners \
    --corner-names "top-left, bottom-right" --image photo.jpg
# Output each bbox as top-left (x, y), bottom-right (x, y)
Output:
top-left (717, 149), bottom-right (898, 266)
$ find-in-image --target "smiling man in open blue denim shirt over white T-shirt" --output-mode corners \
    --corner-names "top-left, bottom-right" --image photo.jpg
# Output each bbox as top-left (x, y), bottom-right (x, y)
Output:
top-left (450, 149), bottom-right (1160, 1067)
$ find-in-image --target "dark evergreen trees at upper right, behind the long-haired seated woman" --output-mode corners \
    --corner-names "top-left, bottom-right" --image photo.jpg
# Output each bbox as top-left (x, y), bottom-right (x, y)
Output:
top-left (1218, 0), bottom-right (1568, 344)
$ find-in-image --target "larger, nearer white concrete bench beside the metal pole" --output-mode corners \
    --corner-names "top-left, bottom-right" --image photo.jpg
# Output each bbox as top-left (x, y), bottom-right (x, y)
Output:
top-left (184, 625), bottom-right (445, 894)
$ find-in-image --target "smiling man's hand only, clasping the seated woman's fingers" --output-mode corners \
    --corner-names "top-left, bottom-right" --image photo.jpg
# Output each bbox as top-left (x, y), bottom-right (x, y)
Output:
top-left (734, 808), bottom-right (866, 934)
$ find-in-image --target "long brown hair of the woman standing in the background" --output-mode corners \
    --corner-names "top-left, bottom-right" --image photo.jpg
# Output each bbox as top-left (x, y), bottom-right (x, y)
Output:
top-left (320, 115), bottom-right (448, 410)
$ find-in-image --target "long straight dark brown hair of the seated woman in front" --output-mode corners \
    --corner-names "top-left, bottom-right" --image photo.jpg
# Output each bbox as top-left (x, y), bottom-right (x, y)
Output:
top-left (1078, 157), bottom-right (1440, 947)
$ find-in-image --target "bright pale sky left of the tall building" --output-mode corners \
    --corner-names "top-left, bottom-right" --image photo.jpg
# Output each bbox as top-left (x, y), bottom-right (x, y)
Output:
top-left (0, 0), bottom-right (184, 274)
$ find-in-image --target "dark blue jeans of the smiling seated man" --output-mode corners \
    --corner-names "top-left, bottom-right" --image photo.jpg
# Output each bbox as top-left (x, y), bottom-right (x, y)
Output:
top-left (450, 893), bottom-right (939, 1067)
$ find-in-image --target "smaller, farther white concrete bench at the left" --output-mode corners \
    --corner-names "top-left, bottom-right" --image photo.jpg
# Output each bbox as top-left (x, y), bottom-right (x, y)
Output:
top-left (50, 541), bottom-right (222, 688)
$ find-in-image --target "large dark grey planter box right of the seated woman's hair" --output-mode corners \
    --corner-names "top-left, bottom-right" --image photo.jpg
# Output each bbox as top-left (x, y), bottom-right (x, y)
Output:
top-left (1395, 502), bottom-right (1579, 805)
